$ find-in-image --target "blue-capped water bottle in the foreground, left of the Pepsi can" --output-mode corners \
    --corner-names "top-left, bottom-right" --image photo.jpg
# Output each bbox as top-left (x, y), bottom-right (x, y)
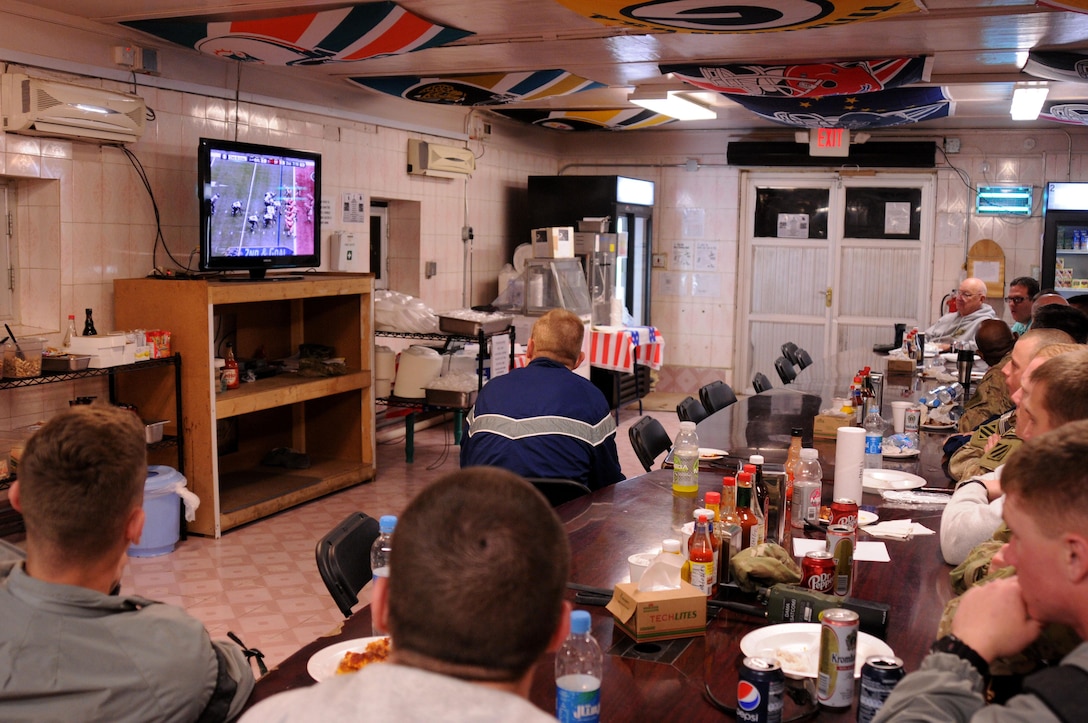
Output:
top-left (555, 610), bottom-right (604, 723)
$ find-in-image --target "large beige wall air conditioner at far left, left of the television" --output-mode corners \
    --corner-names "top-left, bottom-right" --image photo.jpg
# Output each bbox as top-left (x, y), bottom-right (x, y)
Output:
top-left (0, 73), bottom-right (147, 144)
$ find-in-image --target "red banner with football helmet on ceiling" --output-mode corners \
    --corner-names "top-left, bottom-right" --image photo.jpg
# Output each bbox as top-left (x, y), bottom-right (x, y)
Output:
top-left (659, 55), bottom-right (930, 98)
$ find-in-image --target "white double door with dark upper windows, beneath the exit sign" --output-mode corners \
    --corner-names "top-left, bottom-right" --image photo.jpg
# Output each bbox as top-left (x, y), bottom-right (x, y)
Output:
top-left (734, 172), bottom-right (935, 388)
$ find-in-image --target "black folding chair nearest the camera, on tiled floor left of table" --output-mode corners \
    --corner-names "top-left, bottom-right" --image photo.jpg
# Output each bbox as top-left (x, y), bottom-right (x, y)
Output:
top-left (317, 512), bottom-right (379, 618)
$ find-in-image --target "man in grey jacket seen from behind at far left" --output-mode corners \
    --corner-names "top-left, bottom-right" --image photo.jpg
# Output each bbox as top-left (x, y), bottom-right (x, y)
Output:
top-left (0, 404), bottom-right (254, 722)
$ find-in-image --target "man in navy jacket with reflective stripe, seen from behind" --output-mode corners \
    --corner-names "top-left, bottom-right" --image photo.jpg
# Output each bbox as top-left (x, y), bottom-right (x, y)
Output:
top-left (461, 309), bottom-right (623, 489)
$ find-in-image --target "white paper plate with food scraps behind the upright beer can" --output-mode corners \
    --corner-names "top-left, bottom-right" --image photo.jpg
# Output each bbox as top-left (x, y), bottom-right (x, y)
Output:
top-left (741, 623), bottom-right (895, 678)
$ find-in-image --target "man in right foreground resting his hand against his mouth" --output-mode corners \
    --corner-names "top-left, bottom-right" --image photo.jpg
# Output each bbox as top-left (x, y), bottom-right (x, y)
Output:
top-left (876, 419), bottom-right (1088, 723)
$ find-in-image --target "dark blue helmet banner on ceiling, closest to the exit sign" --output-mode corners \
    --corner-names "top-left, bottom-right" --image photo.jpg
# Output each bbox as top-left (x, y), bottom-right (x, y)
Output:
top-left (726, 87), bottom-right (954, 129)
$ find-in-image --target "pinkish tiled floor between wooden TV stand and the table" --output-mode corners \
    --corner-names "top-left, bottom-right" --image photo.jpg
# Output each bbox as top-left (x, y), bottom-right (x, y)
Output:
top-left (122, 410), bottom-right (679, 668)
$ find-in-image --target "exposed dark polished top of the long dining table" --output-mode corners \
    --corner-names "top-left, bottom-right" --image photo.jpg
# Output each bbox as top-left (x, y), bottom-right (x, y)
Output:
top-left (250, 369), bottom-right (951, 721)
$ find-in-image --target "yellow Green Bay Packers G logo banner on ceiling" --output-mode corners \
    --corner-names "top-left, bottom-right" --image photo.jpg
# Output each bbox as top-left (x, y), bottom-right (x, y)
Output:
top-left (559, 0), bottom-right (919, 33)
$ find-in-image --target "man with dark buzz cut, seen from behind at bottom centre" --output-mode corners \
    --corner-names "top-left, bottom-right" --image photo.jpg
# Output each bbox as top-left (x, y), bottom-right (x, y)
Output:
top-left (244, 468), bottom-right (570, 723)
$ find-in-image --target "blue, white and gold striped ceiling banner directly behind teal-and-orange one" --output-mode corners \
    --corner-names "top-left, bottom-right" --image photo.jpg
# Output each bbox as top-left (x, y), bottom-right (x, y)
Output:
top-left (348, 70), bottom-right (605, 105)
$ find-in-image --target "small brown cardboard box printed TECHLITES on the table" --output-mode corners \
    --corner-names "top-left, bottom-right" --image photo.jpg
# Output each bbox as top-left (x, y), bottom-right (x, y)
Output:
top-left (608, 582), bottom-right (706, 643)
